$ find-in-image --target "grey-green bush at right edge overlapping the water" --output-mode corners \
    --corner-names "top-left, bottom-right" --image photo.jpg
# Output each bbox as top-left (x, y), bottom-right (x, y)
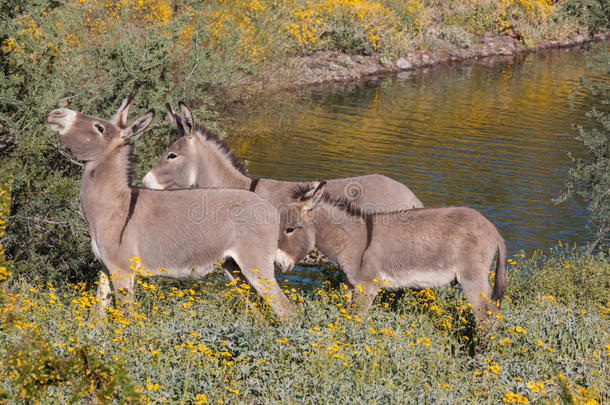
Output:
top-left (560, 44), bottom-right (610, 251)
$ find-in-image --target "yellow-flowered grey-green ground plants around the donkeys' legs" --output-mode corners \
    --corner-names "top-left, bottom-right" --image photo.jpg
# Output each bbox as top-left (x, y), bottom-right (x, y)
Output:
top-left (0, 258), bottom-right (610, 404)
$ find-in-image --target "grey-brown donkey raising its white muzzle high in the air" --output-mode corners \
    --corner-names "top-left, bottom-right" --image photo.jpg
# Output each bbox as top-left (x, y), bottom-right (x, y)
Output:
top-left (47, 97), bottom-right (294, 320)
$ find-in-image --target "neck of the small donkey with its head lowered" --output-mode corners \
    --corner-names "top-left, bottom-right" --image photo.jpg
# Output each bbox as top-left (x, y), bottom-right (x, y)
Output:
top-left (312, 202), bottom-right (372, 268)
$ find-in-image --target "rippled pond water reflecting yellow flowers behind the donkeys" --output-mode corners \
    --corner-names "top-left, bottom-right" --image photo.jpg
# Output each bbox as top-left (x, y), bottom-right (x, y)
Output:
top-left (224, 49), bottom-right (594, 280)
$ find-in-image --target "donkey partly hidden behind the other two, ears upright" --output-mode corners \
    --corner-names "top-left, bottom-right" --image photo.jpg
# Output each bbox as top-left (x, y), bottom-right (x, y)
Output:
top-left (143, 102), bottom-right (423, 266)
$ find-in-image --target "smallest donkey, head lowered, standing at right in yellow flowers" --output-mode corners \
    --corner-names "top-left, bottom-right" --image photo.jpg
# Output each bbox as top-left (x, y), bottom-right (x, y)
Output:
top-left (278, 180), bottom-right (506, 322)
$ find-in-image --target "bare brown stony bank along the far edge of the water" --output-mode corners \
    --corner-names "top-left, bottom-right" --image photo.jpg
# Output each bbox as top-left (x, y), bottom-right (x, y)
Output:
top-left (235, 31), bottom-right (610, 101)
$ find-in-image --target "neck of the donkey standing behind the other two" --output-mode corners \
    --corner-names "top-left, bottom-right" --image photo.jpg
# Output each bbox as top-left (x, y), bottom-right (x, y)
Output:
top-left (197, 137), bottom-right (252, 189)
